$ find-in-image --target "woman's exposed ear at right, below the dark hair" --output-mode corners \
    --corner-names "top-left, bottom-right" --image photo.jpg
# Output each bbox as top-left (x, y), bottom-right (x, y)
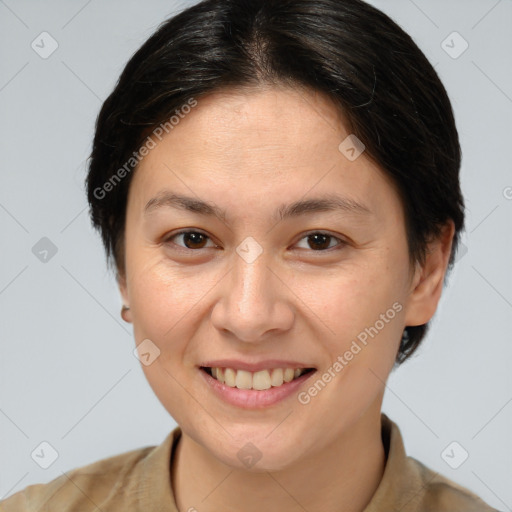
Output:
top-left (405, 220), bottom-right (455, 326)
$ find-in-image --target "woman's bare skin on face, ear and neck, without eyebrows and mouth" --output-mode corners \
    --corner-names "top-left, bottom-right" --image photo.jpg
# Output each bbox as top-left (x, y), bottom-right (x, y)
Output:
top-left (119, 86), bottom-right (454, 512)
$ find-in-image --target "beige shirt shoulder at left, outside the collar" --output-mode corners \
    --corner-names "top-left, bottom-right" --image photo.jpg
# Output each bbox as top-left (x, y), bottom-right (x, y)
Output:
top-left (0, 437), bottom-right (169, 512)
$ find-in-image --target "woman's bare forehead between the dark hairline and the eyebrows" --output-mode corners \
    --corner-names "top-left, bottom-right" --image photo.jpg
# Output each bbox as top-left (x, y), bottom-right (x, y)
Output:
top-left (126, 87), bottom-right (398, 223)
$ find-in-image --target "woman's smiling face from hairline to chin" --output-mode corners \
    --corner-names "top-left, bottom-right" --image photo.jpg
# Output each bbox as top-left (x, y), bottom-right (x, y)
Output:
top-left (120, 88), bottom-right (446, 470)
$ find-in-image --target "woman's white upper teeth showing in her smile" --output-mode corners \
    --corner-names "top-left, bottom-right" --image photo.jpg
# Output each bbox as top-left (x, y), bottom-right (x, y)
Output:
top-left (211, 368), bottom-right (306, 390)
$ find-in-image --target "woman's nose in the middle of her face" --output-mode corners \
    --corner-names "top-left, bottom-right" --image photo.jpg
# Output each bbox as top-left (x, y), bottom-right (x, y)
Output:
top-left (211, 246), bottom-right (294, 343)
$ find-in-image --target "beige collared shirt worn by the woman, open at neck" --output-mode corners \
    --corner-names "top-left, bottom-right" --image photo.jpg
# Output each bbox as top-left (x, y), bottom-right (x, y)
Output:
top-left (0, 413), bottom-right (497, 512)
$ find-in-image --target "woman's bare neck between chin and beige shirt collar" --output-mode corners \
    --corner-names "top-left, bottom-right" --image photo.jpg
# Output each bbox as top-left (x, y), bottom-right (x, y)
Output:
top-left (171, 404), bottom-right (386, 512)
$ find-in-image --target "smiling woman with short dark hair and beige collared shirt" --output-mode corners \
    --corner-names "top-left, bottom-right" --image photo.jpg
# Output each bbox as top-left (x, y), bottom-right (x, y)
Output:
top-left (1, 0), bottom-right (500, 512)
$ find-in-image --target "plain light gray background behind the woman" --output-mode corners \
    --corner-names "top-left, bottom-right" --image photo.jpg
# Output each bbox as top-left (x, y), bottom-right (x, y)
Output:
top-left (0, 0), bottom-right (512, 510)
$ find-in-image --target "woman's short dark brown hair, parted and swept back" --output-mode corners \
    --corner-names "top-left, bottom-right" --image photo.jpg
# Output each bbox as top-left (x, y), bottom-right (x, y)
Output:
top-left (86, 0), bottom-right (464, 364)
